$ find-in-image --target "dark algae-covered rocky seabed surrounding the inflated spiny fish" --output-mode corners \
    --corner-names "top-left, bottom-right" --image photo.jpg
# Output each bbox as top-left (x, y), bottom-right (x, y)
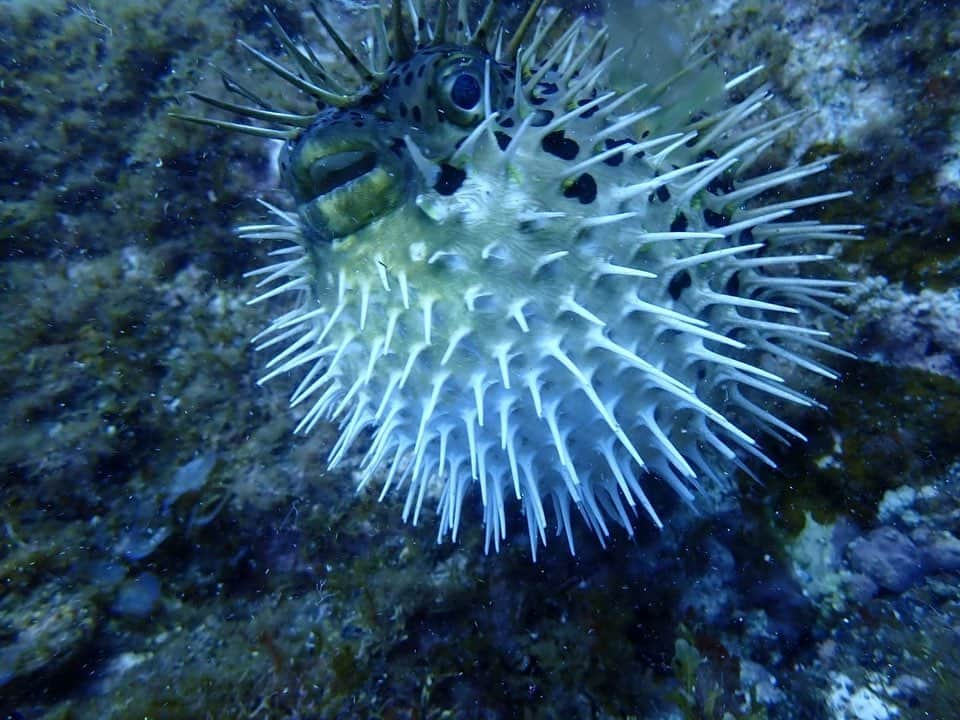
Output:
top-left (0, 0), bottom-right (960, 720)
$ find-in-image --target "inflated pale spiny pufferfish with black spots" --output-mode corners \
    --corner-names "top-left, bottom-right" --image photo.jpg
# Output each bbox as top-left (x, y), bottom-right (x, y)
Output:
top-left (181, 0), bottom-right (860, 559)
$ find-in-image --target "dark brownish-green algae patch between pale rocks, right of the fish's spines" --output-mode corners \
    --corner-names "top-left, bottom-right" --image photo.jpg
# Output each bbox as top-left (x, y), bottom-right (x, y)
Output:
top-left (764, 362), bottom-right (960, 532)
